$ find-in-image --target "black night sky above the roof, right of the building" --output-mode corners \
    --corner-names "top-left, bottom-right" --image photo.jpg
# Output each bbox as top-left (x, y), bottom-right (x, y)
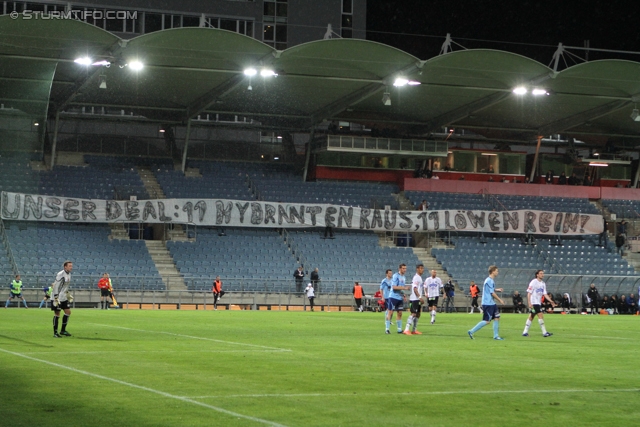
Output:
top-left (367, 0), bottom-right (640, 65)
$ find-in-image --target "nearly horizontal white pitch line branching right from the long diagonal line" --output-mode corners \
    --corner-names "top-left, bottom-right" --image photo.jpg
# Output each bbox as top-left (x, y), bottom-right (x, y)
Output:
top-left (190, 388), bottom-right (640, 399)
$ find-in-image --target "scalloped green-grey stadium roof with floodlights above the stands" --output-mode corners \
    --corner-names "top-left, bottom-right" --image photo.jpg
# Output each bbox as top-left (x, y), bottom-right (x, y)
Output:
top-left (0, 15), bottom-right (640, 145)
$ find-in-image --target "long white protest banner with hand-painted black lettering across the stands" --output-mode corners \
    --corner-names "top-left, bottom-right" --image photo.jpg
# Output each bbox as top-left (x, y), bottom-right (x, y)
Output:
top-left (1, 191), bottom-right (603, 235)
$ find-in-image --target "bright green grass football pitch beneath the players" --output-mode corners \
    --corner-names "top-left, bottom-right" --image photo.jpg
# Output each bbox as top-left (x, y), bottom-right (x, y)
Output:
top-left (0, 309), bottom-right (640, 427)
